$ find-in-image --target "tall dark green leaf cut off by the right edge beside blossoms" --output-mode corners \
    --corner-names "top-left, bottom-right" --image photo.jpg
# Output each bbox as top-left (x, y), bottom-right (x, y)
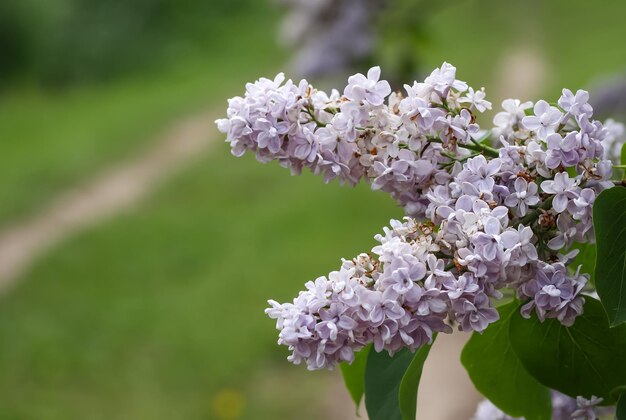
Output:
top-left (593, 187), bottom-right (626, 325)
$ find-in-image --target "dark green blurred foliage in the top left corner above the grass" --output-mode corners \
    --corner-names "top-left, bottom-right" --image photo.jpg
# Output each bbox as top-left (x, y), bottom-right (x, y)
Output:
top-left (0, 0), bottom-right (269, 85)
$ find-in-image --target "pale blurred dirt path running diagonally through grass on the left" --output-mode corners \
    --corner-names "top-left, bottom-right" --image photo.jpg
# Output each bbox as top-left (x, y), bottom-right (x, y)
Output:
top-left (0, 111), bottom-right (216, 292)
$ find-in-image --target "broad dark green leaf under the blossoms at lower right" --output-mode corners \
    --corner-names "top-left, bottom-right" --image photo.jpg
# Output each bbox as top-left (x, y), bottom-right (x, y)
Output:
top-left (509, 296), bottom-right (626, 404)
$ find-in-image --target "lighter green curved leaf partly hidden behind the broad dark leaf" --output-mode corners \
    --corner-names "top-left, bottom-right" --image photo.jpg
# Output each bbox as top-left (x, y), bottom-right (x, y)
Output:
top-left (461, 302), bottom-right (552, 420)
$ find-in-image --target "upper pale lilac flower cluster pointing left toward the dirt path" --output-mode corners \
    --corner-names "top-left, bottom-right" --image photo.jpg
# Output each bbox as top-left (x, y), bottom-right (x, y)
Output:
top-left (217, 63), bottom-right (491, 216)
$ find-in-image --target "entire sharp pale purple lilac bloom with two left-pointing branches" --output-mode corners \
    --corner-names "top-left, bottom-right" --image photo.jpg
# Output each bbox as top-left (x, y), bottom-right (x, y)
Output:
top-left (216, 63), bottom-right (615, 369)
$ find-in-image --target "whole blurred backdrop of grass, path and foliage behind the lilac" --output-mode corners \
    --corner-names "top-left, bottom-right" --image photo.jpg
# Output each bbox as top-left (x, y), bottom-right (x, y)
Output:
top-left (0, 0), bottom-right (626, 420)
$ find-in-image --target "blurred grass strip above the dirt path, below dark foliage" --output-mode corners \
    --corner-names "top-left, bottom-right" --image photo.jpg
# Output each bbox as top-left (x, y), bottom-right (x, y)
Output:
top-left (0, 10), bottom-right (280, 227)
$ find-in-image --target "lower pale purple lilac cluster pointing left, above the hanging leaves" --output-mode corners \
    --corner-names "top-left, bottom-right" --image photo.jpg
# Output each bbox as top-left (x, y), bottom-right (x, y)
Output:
top-left (266, 218), bottom-right (488, 369)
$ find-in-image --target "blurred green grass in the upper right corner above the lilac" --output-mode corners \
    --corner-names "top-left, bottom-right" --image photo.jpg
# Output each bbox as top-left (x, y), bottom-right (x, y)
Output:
top-left (414, 0), bottom-right (626, 99)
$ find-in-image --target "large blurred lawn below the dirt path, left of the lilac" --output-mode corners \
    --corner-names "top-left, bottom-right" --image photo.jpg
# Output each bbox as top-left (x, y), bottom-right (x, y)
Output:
top-left (0, 148), bottom-right (401, 419)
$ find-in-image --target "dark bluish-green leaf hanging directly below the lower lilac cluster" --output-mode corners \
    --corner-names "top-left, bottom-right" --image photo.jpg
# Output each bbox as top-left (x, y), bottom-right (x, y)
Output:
top-left (365, 338), bottom-right (430, 420)
